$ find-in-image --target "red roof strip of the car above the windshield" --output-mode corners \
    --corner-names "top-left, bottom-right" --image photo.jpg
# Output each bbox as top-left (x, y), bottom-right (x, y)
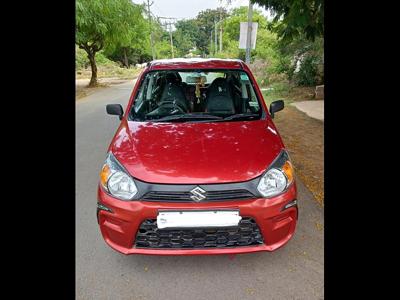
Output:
top-left (147, 58), bottom-right (245, 70)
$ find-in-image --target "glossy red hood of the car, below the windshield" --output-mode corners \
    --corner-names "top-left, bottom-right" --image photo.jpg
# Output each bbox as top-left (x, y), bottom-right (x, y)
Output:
top-left (110, 120), bottom-right (283, 184)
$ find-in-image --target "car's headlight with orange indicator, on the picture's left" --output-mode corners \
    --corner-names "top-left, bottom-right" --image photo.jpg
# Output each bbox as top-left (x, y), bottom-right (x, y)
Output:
top-left (100, 152), bottom-right (137, 200)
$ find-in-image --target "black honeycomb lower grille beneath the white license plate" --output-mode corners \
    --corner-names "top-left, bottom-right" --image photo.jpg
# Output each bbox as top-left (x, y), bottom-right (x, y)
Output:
top-left (134, 218), bottom-right (263, 249)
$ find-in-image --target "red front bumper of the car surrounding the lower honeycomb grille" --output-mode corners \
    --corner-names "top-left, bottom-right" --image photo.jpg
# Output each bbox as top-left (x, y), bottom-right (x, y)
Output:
top-left (97, 184), bottom-right (298, 255)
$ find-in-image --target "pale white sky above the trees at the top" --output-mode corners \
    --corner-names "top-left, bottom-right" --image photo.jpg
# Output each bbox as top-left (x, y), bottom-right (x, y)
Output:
top-left (132, 0), bottom-right (268, 19)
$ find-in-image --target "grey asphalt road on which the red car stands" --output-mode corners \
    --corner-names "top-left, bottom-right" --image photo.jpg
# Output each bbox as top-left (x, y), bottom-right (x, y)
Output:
top-left (76, 82), bottom-right (324, 300)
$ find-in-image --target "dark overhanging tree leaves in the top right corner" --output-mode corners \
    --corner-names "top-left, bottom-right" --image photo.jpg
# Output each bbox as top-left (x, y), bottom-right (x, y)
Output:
top-left (252, 0), bottom-right (324, 43)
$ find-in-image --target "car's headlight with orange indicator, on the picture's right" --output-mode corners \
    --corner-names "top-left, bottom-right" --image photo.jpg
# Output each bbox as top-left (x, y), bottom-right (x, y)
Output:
top-left (257, 150), bottom-right (294, 197)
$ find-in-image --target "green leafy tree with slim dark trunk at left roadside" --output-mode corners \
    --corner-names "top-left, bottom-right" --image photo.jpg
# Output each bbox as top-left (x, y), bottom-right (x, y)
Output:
top-left (75, 0), bottom-right (141, 86)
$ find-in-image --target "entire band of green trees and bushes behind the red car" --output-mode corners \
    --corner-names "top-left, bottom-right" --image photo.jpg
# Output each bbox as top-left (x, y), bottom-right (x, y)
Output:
top-left (76, 0), bottom-right (324, 87)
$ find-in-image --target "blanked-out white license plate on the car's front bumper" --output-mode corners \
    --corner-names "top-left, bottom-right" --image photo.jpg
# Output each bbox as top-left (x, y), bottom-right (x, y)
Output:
top-left (157, 210), bottom-right (242, 229)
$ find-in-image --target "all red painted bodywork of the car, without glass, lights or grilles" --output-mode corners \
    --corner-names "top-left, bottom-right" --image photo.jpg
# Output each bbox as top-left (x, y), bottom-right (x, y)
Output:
top-left (98, 59), bottom-right (297, 255)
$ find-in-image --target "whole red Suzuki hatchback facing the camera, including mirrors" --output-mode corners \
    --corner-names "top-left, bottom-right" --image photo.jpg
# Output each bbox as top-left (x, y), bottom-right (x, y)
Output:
top-left (97, 59), bottom-right (298, 255)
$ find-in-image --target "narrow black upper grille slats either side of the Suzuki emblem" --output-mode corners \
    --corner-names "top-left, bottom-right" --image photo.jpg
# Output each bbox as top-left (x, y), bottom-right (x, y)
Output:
top-left (141, 190), bottom-right (255, 202)
